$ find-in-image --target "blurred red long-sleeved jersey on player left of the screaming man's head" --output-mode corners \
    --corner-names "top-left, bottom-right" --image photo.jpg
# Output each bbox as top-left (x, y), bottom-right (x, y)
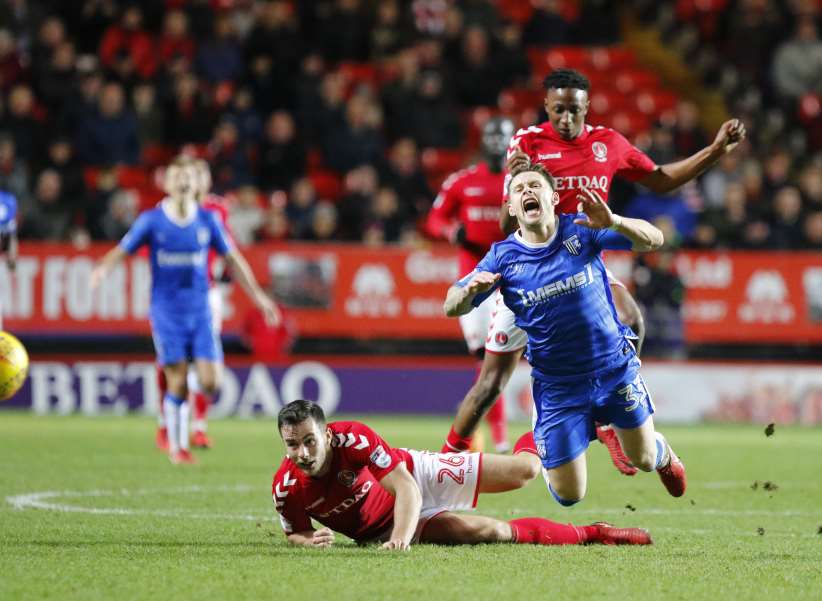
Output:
top-left (425, 163), bottom-right (505, 274)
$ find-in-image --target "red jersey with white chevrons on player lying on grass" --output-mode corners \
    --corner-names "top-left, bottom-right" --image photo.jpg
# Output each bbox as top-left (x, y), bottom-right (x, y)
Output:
top-left (271, 422), bottom-right (413, 541)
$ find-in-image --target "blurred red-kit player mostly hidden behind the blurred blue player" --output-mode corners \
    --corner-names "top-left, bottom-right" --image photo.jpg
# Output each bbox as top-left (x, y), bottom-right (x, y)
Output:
top-left (155, 159), bottom-right (233, 451)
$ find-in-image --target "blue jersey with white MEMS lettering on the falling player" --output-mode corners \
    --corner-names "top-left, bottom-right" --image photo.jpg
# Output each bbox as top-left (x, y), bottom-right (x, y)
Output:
top-left (457, 215), bottom-right (632, 379)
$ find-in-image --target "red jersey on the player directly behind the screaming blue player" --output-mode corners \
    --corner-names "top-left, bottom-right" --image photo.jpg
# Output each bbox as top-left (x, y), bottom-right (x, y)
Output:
top-left (504, 121), bottom-right (656, 213)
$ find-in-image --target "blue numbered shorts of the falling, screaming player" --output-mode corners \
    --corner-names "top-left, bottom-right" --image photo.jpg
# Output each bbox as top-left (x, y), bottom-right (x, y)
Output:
top-left (532, 357), bottom-right (654, 469)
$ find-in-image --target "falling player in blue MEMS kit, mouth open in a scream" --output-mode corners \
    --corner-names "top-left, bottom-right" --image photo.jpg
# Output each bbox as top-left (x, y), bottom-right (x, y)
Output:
top-left (444, 164), bottom-right (686, 506)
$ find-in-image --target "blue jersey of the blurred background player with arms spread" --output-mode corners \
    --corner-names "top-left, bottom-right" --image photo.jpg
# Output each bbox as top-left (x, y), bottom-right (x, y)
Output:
top-left (120, 204), bottom-right (231, 312)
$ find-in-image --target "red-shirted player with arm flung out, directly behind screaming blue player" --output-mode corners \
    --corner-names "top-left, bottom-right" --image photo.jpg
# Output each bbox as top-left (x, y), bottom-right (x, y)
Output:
top-left (447, 69), bottom-right (745, 486)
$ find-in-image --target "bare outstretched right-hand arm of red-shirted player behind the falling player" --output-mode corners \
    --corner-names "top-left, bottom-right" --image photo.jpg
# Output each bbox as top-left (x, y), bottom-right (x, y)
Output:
top-left (639, 119), bottom-right (745, 193)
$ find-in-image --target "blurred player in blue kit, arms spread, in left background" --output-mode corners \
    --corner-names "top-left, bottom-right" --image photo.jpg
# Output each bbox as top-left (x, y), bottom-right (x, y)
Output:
top-left (91, 158), bottom-right (279, 463)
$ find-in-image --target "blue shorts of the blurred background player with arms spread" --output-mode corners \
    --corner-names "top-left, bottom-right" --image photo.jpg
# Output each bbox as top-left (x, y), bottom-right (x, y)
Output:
top-left (151, 308), bottom-right (223, 365)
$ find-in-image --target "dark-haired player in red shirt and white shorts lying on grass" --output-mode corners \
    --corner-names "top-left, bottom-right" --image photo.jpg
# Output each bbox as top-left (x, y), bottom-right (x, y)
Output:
top-left (272, 400), bottom-right (651, 550)
